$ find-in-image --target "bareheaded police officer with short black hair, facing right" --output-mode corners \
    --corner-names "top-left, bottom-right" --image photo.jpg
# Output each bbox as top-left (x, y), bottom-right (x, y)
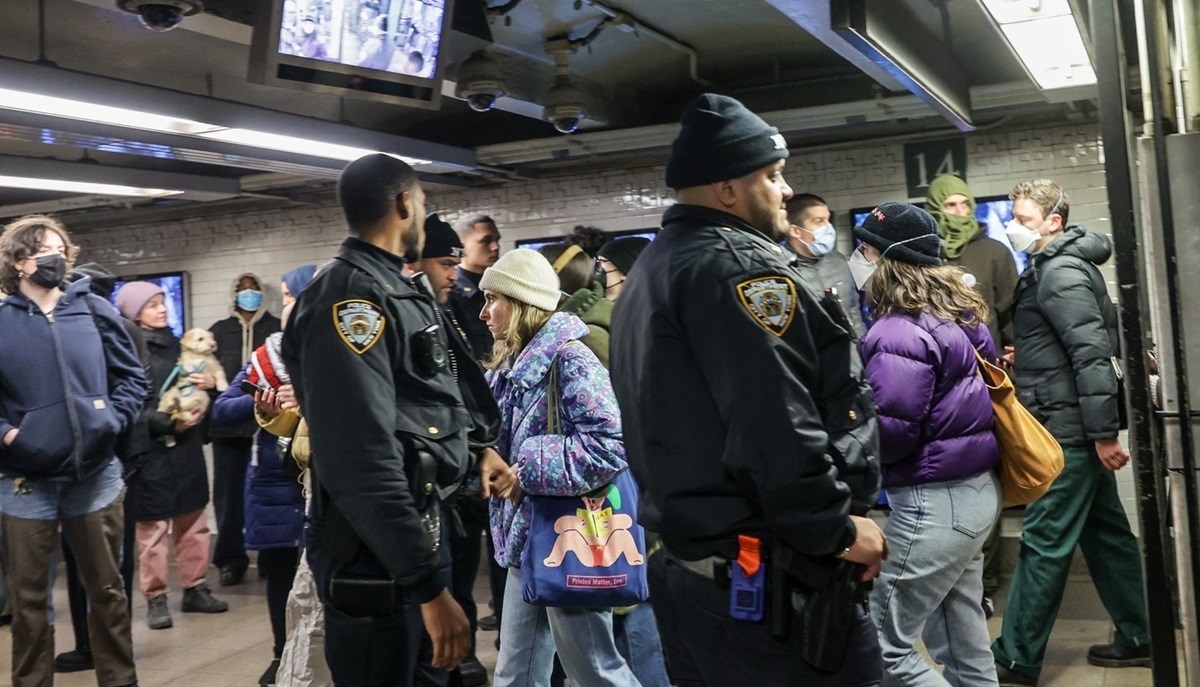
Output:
top-left (283, 154), bottom-right (472, 687)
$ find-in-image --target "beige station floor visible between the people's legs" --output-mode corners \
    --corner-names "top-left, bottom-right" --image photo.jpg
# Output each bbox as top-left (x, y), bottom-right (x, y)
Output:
top-left (0, 557), bottom-right (1152, 687)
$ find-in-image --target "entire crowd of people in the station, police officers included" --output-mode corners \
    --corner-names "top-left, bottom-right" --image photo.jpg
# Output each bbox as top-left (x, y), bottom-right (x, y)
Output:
top-left (0, 95), bottom-right (1150, 687)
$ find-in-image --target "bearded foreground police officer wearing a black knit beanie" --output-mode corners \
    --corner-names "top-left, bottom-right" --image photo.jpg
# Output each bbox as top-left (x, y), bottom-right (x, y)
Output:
top-left (612, 94), bottom-right (886, 686)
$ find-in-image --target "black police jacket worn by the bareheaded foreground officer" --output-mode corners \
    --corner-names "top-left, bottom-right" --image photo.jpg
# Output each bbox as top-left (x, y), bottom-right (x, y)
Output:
top-left (283, 237), bottom-right (470, 603)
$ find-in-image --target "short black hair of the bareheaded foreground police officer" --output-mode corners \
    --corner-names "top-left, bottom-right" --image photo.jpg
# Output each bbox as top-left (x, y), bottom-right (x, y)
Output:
top-left (337, 153), bottom-right (416, 234)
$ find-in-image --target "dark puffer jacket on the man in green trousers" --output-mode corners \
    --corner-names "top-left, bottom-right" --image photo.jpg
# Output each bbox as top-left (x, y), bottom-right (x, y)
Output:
top-left (1013, 226), bottom-right (1123, 448)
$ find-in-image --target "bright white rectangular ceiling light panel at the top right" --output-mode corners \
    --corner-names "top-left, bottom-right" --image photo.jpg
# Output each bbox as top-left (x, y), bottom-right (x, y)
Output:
top-left (982, 0), bottom-right (1096, 90)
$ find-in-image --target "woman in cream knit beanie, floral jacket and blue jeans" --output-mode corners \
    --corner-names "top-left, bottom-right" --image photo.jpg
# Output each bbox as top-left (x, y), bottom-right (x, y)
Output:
top-left (479, 249), bottom-right (640, 687)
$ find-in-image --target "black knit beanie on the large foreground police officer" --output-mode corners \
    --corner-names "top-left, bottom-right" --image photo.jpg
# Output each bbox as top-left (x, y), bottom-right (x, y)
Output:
top-left (667, 92), bottom-right (787, 189)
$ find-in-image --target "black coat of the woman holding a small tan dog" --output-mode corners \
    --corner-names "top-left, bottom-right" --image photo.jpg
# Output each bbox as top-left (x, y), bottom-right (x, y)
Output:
top-left (127, 329), bottom-right (209, 521)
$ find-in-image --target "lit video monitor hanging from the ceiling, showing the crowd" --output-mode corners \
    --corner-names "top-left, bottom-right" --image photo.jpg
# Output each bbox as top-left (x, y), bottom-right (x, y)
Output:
top-left (247, 0), bottom-right (452, 109)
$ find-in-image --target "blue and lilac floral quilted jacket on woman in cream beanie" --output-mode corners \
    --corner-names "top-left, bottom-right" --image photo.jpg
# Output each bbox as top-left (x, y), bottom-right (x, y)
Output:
top-left (488, 312), bottom-right (626, 568)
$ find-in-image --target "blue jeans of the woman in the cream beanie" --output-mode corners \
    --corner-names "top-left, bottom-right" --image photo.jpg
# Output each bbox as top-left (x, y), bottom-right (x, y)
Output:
top-left (493, 568), bottom-right (641, 687)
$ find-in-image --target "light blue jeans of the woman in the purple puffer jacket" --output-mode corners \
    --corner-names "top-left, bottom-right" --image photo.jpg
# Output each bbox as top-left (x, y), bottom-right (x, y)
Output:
top-left (871, 471), bottom-right (1001, 687)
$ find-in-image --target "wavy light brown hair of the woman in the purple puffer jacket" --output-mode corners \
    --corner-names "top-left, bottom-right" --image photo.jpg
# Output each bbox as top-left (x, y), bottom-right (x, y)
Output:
top-left (868, 258), bottom-right (988, 325)
